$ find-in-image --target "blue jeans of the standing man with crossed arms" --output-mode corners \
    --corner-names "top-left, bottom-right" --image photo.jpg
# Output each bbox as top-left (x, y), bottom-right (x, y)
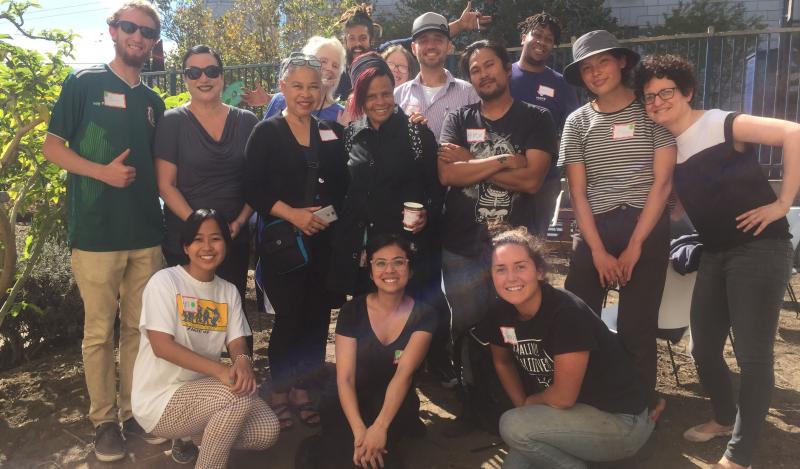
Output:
top-left (442, 249), bottom-right (495, 384)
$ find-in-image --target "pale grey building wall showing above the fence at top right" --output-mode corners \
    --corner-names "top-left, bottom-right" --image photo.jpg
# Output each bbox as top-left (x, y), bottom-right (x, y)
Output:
top-left (605, 0), bottom-right (786, 27)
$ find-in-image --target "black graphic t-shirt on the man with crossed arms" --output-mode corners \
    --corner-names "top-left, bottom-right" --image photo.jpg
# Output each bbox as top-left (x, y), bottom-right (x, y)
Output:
top-left (440, 100), bottom-right (556, 256)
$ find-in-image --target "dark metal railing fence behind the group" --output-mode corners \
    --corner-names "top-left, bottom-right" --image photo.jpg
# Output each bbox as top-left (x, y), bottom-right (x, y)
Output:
top-left (143, 27), bottom-right (800, 179)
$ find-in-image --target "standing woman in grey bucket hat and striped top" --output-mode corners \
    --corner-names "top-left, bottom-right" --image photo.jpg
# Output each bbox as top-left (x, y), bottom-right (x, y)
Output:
top-left (558, 31), bottom-right (676, 419)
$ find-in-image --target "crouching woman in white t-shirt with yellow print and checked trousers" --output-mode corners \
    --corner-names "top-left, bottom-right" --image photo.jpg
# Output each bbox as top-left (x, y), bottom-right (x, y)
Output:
top-left (131, 209), bottom-right (280, 468)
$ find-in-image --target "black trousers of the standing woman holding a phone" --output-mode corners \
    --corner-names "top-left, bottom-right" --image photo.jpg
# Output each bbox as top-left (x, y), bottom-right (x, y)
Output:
top-left (263, 262), bottom-right (332, 392)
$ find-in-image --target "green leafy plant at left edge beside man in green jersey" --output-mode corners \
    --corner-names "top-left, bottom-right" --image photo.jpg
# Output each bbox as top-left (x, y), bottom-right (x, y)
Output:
top-left (0, 0), bottom-right (74, 330)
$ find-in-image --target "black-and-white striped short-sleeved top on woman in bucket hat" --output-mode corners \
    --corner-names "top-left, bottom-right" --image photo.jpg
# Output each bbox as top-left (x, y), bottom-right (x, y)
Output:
top-left (558, 100), bottom-right (675, 214)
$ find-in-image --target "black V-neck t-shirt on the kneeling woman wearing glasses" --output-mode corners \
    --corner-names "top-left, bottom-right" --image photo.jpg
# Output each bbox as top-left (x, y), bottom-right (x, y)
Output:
top-left (336, 295), bottom-right (436, 399)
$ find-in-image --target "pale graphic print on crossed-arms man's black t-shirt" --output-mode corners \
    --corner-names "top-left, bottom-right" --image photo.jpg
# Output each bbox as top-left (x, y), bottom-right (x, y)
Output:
top-left (462, 129), bottom-right (522, 225)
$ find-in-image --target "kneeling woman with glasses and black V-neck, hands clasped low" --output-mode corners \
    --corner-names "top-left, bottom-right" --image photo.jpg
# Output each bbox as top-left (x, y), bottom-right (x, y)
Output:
top-left (295, 234), bottom-right (436, 469)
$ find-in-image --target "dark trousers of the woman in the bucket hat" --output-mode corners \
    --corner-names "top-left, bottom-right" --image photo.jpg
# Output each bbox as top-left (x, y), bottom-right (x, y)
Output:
top-left (564, 205), bottom-right (669, 405)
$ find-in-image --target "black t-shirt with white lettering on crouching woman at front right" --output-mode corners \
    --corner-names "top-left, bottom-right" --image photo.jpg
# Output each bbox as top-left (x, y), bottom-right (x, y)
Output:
top-left (481, 283), bottom-right (646, 414)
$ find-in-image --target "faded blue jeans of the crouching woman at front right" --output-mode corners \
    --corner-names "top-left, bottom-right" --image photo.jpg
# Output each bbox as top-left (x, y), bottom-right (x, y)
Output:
top-left (500, 404), bottom-right (655, 469)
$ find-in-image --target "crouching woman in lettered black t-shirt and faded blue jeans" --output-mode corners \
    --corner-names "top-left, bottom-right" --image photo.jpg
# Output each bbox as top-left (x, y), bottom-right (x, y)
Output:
top-left (484, 228), bottom-right (654, 469)
